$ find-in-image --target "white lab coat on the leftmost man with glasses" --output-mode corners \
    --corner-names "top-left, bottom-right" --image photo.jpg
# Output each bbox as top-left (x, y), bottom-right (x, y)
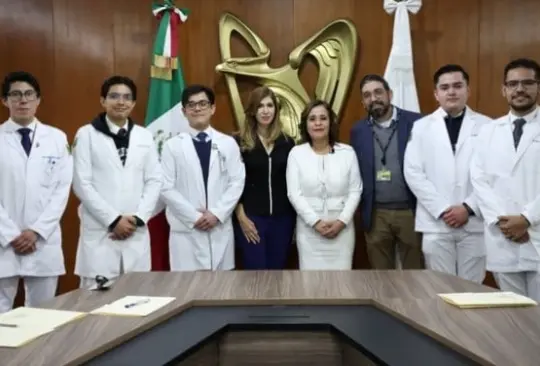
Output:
top-left (0, 119), bottom-right (73, 278)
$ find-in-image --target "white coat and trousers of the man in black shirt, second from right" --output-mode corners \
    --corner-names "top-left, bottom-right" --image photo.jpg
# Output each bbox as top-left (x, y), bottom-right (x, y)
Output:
top-left (404, 107), bottom-right (491, 282)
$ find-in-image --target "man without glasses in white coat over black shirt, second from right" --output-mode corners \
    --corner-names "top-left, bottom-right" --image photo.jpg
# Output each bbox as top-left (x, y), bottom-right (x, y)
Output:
top-left (404, 65), bottom-right (490, 283)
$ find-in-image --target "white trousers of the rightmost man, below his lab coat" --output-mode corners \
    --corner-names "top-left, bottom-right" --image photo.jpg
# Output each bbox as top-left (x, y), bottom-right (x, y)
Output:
top-left (493, 271), bottom-right (540, 301)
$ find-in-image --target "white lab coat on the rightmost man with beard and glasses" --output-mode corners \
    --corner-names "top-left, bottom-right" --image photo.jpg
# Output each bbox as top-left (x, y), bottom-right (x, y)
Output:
top-left (471, 108), bottom-right (540, 272)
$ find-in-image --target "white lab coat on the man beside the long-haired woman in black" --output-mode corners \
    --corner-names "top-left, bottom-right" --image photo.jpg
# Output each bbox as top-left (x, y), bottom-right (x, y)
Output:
top-left (161, 127), bottom-right (246, 271)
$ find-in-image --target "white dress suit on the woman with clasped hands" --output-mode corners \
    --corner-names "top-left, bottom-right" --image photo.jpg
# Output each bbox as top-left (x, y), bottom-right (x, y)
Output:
top-left (287, 143), bottom-right (362, 270)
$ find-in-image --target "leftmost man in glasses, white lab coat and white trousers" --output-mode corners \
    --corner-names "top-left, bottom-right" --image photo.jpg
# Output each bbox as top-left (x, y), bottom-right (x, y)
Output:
top-left (0, 72), bottom-right (73, 313)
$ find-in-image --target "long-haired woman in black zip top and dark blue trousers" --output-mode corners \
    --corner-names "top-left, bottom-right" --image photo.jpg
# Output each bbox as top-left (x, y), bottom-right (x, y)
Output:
top-left (234, 86), bottom-right (296, 270)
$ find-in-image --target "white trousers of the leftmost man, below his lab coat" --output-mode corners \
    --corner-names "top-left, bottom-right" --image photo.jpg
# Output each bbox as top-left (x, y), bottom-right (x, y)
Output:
top-left (0, 276), bottom-right (58, 313)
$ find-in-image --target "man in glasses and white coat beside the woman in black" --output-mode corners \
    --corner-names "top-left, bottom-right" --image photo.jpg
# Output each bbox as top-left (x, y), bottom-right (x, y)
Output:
top-left (161, 85), bottom-right (245, 271)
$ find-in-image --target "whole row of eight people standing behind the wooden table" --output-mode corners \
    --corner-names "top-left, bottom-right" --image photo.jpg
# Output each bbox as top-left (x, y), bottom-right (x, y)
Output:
top-left (0, 55), bottom-right (540, 312)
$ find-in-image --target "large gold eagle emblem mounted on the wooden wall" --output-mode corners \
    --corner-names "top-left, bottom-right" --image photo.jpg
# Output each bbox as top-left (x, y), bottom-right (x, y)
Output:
top-left (216, 13), bottom-right (358, 139)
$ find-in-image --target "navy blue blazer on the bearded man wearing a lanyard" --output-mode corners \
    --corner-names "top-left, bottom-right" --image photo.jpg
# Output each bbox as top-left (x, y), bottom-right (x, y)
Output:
top-left (350, 107), bottom-right (422, 231)
